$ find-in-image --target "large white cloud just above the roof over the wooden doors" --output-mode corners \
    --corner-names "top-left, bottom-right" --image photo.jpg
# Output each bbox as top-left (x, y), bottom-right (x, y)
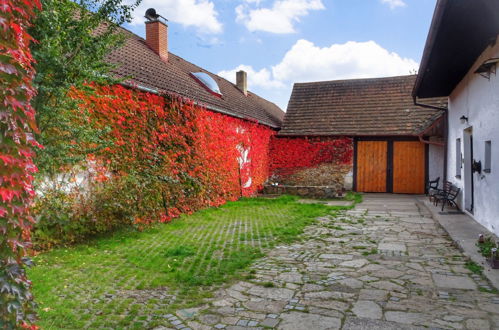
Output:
top-left (219, 39), bottom-right (418, 109)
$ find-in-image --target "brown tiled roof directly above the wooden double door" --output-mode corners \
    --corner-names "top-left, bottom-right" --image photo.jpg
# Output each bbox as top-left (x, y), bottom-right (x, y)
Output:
top-left (279, 75), bottom-right (446, 136)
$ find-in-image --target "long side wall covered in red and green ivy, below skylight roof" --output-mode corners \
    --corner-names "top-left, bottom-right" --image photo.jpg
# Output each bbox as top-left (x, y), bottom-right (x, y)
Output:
top-left (67, 86), bottom-right (275, 223)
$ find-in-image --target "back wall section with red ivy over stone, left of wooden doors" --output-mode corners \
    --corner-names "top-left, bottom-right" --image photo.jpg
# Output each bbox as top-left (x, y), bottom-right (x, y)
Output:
top-left (270, 137), bottom-right (353, 185)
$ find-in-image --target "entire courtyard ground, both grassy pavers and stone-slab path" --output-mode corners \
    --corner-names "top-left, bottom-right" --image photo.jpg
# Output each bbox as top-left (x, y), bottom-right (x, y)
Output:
top-left (30, 195), bottom-right (499, 330)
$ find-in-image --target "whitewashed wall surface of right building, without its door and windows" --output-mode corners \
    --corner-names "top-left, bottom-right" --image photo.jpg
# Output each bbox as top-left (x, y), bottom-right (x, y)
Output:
top-left (447, 37), bottom-right (499, 235)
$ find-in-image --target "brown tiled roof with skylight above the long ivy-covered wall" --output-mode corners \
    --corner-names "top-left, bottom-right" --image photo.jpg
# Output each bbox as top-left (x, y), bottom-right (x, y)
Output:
top-left (108, 29), bottom-right (284, 128)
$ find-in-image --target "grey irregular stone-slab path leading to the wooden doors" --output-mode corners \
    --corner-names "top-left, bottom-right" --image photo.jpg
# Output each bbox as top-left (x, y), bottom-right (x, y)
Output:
top-left (165, 195), bottom-right (499, 330)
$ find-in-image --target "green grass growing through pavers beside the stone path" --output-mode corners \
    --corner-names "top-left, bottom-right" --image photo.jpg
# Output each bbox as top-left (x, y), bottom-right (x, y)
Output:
top-left (29, 196), bottom-right (356, 329)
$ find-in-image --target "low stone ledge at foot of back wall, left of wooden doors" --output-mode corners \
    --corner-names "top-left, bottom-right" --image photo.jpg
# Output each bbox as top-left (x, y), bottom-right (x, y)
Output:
top-left (263, 184), bottom-right (344, 198)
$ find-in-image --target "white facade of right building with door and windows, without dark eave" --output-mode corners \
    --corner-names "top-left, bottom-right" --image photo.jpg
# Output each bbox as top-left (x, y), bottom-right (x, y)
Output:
top-left (447, 38), bottom-right (499, 235)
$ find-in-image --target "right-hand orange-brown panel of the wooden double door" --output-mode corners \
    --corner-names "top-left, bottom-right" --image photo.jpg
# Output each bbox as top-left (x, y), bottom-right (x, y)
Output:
top-left (393, 141), bottom-right (426, 194)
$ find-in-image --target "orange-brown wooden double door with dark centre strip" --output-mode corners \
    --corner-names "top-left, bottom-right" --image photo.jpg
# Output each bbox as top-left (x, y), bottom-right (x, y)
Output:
top-left (355, 140), bottom-right (427, 194)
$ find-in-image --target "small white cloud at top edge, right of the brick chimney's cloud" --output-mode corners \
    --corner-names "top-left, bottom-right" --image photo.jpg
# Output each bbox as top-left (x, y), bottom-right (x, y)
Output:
top-left (236, 0), bottom-right (325, 34)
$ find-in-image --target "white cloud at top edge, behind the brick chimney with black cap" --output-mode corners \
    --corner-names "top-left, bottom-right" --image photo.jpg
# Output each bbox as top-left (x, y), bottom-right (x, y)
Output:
top-left (132, 0), bottom-right (223, 34)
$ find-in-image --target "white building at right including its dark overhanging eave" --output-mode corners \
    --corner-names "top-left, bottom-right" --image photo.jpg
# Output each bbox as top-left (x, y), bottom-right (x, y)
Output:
top-left (413, 0), bottom-right (499, 236)
